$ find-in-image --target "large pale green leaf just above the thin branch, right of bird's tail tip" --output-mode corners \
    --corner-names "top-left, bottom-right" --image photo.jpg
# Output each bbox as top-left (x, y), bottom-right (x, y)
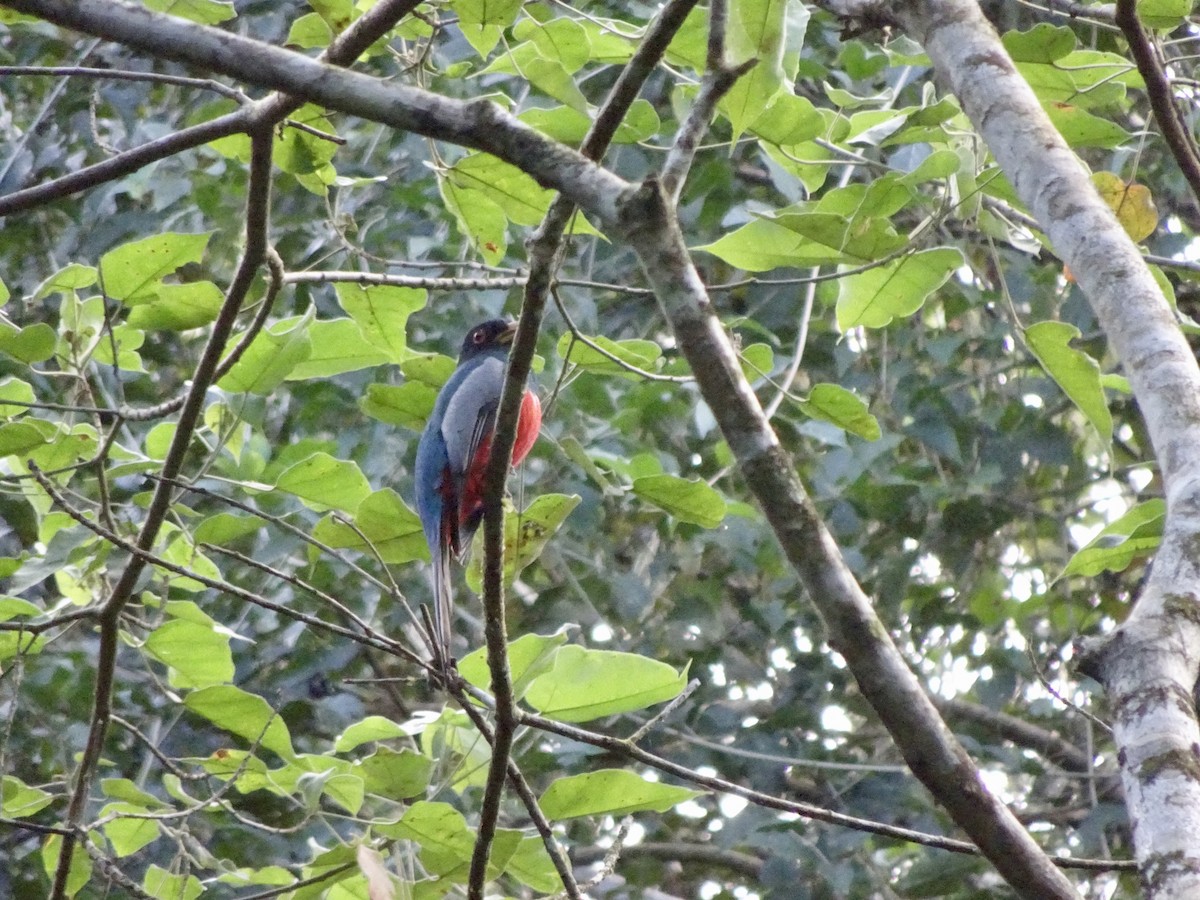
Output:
top-left (526, 644), bottom-right (688, 722)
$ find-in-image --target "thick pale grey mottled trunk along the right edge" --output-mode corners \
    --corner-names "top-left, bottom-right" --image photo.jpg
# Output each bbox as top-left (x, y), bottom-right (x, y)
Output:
top-left (873, 0), bottom-right (1200, 898)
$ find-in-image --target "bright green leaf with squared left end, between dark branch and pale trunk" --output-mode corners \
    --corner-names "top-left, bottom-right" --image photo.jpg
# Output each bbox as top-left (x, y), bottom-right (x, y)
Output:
top-left (838, 247), bottom-right (965, 331)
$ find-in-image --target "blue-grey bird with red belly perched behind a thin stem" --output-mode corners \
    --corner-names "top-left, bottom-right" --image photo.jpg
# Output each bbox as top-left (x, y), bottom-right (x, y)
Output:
top-left (414, 319), bottom-right (541, 668)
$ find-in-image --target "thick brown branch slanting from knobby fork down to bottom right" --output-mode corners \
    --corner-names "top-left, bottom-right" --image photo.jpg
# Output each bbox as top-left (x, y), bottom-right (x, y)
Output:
top-left (622, 182), bottom-right (1076, 899)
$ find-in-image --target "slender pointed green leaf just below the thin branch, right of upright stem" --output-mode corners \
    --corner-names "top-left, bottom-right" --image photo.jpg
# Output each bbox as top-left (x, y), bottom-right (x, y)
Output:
top-left (538, 769), bottom-right (703, 821)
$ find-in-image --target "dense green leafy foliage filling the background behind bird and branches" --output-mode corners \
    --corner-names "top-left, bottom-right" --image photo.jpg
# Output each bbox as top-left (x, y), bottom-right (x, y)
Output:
top-left (0, 0), bottom-right (1195, 898)
